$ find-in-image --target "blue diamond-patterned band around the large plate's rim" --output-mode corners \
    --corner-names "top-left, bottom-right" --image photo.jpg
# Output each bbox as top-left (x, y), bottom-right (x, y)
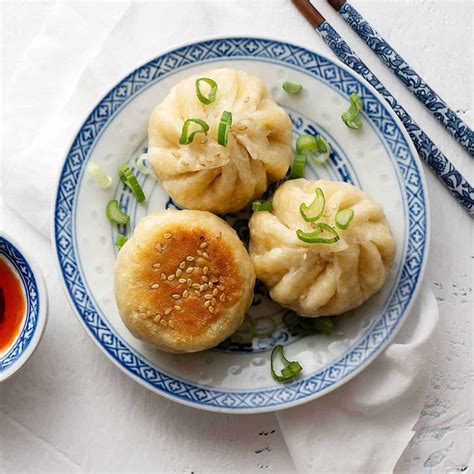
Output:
top-left (54, 38), bottom-right (428, 411)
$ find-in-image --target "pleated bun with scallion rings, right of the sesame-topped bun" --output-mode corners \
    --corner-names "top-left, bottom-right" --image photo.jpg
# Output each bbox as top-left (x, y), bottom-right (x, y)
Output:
top-left (250, 179), bottom-right (395, 317)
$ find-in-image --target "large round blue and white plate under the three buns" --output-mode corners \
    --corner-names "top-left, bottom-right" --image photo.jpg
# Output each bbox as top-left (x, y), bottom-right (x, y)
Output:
top-left (54, 38), bottom-right (429, 413)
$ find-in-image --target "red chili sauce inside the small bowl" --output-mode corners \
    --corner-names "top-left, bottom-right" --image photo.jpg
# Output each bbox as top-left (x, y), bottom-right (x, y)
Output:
top-left (0, 257), bottom-right (26, 353)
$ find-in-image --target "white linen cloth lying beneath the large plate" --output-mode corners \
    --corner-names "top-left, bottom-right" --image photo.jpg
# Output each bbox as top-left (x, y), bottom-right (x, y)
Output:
top-left (3, 0), bottom-right (438, 473)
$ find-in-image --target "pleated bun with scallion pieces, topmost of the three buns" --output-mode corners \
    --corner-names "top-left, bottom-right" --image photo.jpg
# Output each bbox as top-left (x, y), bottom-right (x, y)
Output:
top-left (147, 68), bottom-right (292, 214)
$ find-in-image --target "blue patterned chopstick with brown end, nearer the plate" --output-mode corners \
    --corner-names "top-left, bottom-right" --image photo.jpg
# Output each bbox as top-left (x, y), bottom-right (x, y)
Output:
top-left (292, 0), bottom-right (474, 217)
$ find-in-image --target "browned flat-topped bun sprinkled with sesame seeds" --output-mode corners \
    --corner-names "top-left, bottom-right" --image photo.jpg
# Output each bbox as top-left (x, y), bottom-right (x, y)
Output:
top-left (115, 210), bottom-right (255, 352)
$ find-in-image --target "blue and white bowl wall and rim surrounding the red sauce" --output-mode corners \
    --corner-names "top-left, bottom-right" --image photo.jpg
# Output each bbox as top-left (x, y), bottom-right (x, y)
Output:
top-left (0, 234), bottom-right (48, 382)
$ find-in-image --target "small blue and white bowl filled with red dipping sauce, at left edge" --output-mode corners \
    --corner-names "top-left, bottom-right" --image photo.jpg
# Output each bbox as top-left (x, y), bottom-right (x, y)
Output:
top-left (0, 233), bottom-right (48, 382)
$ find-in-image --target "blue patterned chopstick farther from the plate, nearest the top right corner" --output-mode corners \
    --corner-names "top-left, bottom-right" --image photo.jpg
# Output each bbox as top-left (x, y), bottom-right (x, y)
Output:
top-left (328, 0), bottom-right (474, 156)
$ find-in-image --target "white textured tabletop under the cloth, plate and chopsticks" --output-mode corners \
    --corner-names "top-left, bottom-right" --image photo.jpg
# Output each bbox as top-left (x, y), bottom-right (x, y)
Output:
top-left (0, 0), bottom-right (474, 473)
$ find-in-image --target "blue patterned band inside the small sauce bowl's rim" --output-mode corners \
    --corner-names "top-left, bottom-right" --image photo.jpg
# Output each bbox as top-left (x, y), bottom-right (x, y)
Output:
top-left (0, 237), bottom-right (40, 372)
